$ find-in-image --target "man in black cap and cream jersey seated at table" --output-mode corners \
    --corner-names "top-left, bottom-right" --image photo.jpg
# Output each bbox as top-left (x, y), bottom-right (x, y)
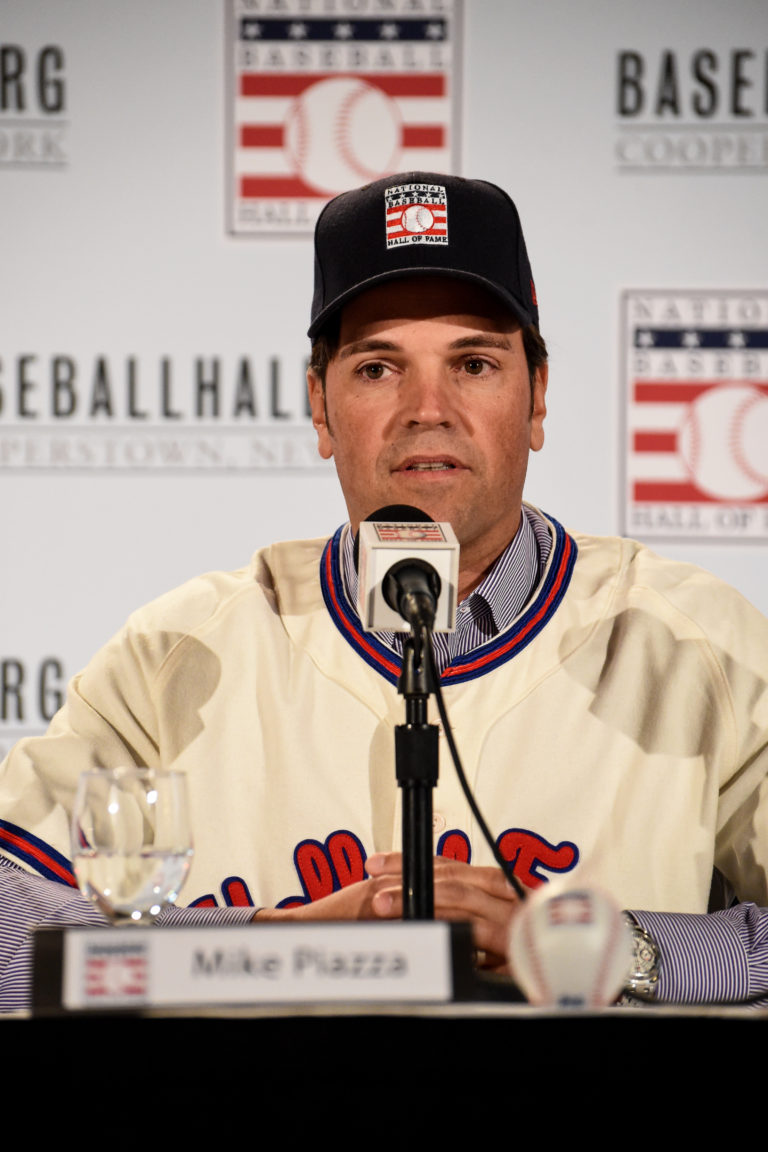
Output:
top-left (0, 173), bottom-right (768, 1005)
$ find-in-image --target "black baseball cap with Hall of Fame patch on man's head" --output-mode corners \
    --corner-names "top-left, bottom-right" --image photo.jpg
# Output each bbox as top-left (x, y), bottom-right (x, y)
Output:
top-left (307, 172), bottom-right (539, 339)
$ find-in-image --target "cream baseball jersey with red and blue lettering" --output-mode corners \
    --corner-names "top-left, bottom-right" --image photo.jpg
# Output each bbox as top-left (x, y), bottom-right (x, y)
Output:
top-left (0, 521), bottom-right (768, 911)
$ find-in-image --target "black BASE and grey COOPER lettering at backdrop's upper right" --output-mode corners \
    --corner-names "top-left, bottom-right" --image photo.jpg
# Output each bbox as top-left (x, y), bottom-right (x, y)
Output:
top-left (615, 45), bottom-right (768, 175)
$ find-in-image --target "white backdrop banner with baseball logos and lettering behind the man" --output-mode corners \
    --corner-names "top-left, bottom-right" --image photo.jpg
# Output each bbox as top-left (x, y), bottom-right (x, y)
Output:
top-left (0, 0), bottom-right (768, 753)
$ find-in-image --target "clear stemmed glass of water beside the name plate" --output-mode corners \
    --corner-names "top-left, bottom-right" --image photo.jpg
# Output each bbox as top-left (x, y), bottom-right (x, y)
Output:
top-left (71, 767), bottom-right (192, 924)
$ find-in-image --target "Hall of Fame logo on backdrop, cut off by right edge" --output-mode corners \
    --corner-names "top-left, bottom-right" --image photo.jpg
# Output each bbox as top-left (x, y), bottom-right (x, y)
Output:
top-left (622, 290), bottom-right (768, 540)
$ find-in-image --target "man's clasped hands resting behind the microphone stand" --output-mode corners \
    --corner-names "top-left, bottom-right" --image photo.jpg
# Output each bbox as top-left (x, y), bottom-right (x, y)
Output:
top-left (253, 852), bottom-right (518, 970)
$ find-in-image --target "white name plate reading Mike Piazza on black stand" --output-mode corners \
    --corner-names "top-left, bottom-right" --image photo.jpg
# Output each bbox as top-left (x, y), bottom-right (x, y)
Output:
top-left (35, 922), bottom-right (470, 1011)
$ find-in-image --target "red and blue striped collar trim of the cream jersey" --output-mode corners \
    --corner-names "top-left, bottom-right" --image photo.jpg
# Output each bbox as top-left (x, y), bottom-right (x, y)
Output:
top-left (320, 516), bottom-right (578, 684)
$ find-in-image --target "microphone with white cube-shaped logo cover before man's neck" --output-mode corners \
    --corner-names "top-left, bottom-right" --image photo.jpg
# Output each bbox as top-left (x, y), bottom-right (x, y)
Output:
top-left (355, 505), bottom-right (458, 632)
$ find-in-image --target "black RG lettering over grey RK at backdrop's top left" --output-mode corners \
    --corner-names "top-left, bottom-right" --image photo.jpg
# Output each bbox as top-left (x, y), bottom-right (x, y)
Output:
top-left (0, 43), bottom-right (69, 169)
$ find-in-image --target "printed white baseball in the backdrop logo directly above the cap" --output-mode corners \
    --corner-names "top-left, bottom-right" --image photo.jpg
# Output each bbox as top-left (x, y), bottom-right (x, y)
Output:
top-left (284, 76), bottom-right (402, 194)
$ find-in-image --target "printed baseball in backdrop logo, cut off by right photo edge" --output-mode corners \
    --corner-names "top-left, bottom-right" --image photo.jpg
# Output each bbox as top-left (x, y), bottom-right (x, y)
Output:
top-left (677, 384), bottom-right (768, 500)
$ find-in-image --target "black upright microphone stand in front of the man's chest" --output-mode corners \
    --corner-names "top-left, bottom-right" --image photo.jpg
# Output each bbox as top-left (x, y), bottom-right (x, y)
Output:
top-left (395, 626), bottom-right (438, 920)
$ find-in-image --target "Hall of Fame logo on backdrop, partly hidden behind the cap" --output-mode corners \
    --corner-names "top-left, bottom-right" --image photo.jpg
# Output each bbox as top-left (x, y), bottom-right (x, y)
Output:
top-left (227, 0), bottom-right (461, 235)
